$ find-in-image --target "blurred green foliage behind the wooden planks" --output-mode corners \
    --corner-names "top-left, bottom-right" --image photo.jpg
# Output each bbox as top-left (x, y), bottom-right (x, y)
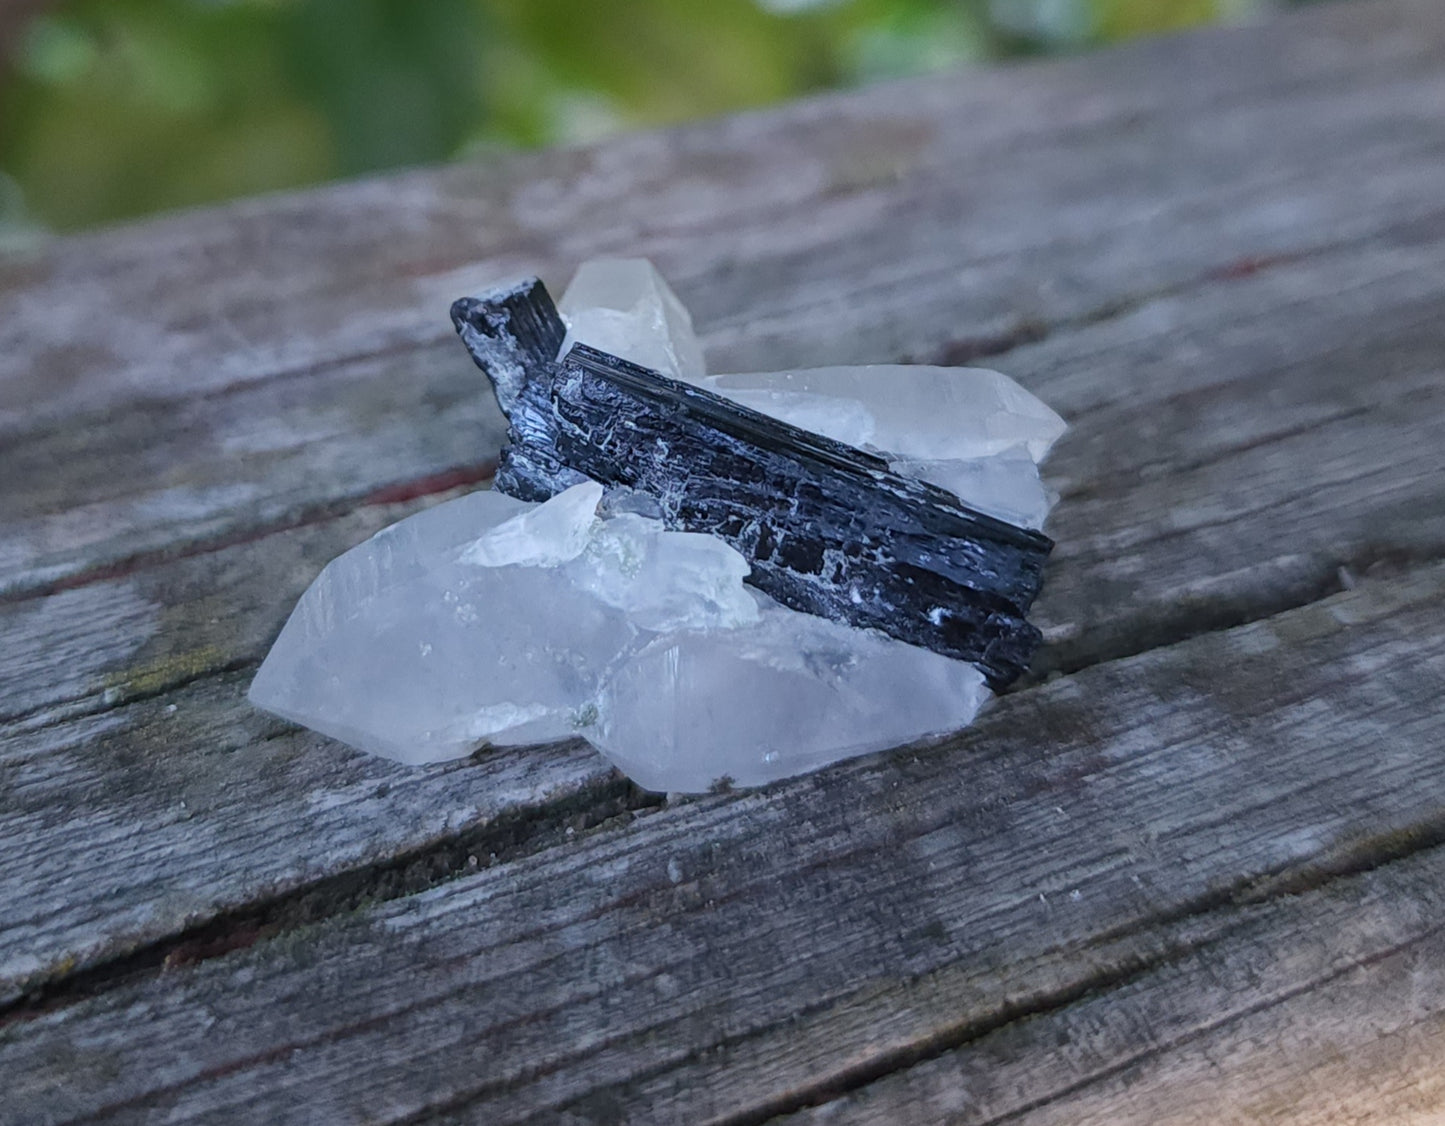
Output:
top-left (0, 0), bottom-right (1270, 237)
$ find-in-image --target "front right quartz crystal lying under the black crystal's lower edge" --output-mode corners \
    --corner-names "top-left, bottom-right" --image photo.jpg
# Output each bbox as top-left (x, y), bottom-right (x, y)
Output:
top-left (587, 598), bottom-right (988, 792)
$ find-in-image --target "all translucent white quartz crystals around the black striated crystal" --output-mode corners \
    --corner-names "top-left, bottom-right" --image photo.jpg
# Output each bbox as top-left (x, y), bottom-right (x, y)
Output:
top-left (250, 259), bottom-right (1064, 792)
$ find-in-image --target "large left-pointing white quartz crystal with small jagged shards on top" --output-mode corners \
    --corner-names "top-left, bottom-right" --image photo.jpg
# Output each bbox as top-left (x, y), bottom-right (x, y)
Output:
top-left (250, 483), bottom-right (757, 763)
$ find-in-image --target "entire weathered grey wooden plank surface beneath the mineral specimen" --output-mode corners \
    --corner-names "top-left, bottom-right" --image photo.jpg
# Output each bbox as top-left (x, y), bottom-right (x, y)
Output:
top-left (0, 1), bottom-right (1445, 1122)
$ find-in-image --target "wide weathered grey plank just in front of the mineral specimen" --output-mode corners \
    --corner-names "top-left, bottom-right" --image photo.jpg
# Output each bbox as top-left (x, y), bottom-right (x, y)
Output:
top-left (0, 567), bottom-right (1445, 1123)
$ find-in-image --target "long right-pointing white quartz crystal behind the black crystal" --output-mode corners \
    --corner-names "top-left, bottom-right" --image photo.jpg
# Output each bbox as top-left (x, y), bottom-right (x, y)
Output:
top-left (696, 364), bottom-right (1065, 463)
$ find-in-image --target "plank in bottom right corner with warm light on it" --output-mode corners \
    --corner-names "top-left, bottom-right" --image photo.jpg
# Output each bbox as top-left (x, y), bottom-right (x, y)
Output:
top-left (779, 848), bottom-right (1445, 1126)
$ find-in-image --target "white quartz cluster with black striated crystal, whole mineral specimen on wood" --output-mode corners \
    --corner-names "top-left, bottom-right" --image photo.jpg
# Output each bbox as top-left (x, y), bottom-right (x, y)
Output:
top-left (250, 260), bottom-right (1062, 791)
